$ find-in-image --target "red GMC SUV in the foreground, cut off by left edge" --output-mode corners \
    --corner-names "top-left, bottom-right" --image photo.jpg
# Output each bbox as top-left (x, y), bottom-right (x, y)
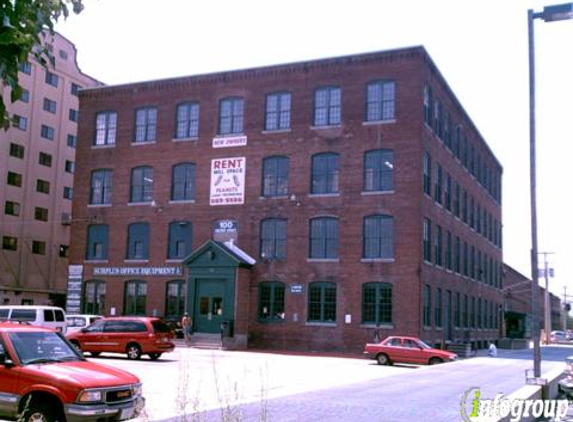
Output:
top-left (0, 322), bottom-right (145, 422)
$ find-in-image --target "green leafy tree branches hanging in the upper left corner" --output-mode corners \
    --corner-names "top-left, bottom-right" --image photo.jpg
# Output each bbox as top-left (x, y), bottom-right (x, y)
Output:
top-left (0, 0), bottom-right (84, 130)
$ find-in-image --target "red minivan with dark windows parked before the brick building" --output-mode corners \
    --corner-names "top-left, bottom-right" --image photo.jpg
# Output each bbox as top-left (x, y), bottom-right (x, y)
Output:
top-left (67, 317), bottom-right (175, 360)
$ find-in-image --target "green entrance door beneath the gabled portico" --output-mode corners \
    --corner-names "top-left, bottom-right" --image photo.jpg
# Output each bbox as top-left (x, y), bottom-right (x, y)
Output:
top-left (195, 279), bottom-right (225, 333)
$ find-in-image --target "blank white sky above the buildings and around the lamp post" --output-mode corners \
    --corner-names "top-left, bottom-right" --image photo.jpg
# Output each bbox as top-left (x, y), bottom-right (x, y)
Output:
top-left (56, 0), bottom-right (573, 301)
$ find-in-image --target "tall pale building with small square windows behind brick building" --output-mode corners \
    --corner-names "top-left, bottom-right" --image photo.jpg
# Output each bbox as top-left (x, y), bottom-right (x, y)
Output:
top-left (0, 34), bottom-right (100, 306)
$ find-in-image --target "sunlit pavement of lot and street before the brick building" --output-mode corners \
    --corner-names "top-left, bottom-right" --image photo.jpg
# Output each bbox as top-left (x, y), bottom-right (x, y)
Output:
top-left (82, 346), bottom-right (573, 422)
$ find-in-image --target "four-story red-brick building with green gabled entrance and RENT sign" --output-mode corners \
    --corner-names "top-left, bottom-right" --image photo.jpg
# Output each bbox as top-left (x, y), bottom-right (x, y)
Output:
top-left (71, 47), bottom-right (502, 350)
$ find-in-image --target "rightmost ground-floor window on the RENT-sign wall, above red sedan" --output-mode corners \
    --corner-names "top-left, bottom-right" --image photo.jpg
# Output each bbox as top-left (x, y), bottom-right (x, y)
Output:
top-left (362, 283), bottom-right (392, 325)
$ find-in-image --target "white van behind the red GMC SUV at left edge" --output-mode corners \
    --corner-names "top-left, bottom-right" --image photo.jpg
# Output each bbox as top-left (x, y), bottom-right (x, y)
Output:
top-left (0, 305), bottom-right (68, 334)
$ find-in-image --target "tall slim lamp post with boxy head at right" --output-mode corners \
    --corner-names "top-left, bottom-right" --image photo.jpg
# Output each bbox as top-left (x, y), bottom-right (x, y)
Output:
top-left (527, 3), bottom-right (573, 378)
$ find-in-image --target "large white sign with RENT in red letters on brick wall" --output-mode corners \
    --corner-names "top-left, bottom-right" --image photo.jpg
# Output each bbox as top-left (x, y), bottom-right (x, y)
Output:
top-left (209, 157), bottom-right (246, 205)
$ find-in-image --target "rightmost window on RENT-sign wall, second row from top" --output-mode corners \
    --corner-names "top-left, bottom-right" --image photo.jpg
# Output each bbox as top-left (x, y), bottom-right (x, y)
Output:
top-left (364, 149), bottom-right (394, 192)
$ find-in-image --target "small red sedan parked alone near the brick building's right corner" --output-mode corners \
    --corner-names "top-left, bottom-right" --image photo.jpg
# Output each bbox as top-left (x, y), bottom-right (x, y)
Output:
top-left (364, 336), bottom-right (458, 365)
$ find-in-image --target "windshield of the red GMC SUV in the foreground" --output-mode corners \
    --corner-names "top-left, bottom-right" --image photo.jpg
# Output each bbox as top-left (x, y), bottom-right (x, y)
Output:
top-left (9, 331), bottom-right (84, 365)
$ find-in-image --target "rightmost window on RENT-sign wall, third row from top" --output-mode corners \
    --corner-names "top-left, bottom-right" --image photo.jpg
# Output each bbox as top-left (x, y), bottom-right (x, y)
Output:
top-left (363, 215), bottom-right (394, 259)
